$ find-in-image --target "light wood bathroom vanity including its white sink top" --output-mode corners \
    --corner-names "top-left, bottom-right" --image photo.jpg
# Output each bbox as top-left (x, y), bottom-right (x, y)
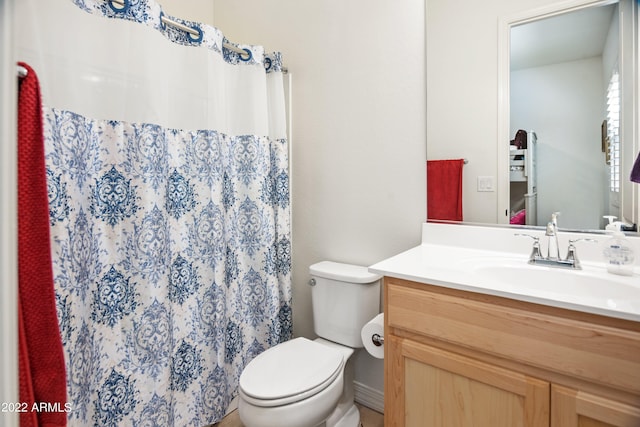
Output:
top-left (370, 224), bottom-right (640, 427)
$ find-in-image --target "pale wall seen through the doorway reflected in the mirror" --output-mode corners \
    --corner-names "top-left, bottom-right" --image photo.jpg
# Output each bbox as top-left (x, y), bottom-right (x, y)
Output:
top-left (510, 57), bottom-right (609, 230)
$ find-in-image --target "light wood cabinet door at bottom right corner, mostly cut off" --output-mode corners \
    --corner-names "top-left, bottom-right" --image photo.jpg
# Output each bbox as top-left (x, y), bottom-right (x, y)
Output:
top-left (551, 385), bottom-right (640, 427)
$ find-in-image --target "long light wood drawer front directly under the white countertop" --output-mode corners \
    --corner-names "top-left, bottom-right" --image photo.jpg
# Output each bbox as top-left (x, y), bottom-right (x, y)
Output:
top-left (385, 278), bottom-right (640, 394)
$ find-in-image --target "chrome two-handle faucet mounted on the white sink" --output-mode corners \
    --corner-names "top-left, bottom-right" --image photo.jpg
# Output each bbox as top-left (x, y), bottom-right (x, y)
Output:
top-left (515, 212), bottom-right (597, 270)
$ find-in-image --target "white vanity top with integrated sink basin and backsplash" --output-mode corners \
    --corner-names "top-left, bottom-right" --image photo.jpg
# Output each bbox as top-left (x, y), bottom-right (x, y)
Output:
top-left (370, 223), bottom-right (640, 322)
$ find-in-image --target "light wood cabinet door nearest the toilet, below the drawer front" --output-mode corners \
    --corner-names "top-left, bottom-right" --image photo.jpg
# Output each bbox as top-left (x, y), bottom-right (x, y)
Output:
top-left (385, 337), bottom-right (550, 427)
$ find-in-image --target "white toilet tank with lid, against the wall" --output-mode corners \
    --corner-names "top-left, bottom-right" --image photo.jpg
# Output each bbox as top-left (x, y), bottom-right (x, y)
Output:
top-left (309, 261), bottom-right (382, 348)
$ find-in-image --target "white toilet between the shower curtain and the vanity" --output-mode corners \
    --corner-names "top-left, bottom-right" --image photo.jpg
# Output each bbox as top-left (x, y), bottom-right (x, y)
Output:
top-left (238, 261), bottom-right (381, 427)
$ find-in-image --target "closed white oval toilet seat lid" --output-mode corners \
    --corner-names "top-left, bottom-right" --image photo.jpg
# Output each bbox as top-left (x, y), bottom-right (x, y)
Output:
top-left (240, 338), bottom-right (345, 407)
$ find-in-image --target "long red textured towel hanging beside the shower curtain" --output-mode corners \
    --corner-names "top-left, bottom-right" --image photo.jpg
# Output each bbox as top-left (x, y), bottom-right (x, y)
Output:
top-left (18, 63), bottom-right (67, 427)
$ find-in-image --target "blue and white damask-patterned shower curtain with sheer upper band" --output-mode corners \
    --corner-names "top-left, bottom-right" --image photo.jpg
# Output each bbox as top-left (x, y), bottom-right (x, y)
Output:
top-left (17, 0), bottom-right (292, 426)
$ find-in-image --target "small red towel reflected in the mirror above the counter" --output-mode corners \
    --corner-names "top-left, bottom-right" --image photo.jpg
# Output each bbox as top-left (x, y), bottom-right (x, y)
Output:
top-left (427, 159), bottom-right (464, 221)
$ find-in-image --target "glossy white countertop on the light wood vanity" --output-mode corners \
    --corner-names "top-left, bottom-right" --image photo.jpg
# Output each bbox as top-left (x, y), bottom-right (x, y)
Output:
top-left (369, 224), bottom-right (640, 322)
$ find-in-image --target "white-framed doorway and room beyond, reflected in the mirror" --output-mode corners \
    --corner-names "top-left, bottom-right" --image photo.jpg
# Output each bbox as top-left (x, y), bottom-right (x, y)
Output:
top-left (497, 0), bottom-right (639, 234)
